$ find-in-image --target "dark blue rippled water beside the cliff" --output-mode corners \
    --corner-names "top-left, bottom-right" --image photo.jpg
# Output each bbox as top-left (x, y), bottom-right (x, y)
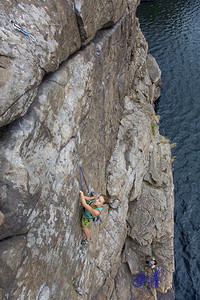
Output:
top-left (137, 0), bottom-right (200, 300)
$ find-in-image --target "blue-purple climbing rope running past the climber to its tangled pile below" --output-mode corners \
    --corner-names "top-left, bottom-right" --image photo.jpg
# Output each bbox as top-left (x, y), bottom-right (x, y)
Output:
top-left (76, 155), bottom-right (166, 300)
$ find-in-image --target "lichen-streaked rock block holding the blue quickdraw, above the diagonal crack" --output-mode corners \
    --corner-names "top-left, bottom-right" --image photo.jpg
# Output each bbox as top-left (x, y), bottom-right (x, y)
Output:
top-left (0, 0), bottom-right (81, 125)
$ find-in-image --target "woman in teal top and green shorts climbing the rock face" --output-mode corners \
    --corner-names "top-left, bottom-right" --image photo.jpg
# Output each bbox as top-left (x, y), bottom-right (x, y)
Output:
top-left (80, 191), bottom-right (109, 245)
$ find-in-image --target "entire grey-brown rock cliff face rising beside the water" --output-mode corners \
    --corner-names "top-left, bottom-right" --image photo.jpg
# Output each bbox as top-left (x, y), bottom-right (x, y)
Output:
top-left (0, 0), bottom-right (174, 300)
